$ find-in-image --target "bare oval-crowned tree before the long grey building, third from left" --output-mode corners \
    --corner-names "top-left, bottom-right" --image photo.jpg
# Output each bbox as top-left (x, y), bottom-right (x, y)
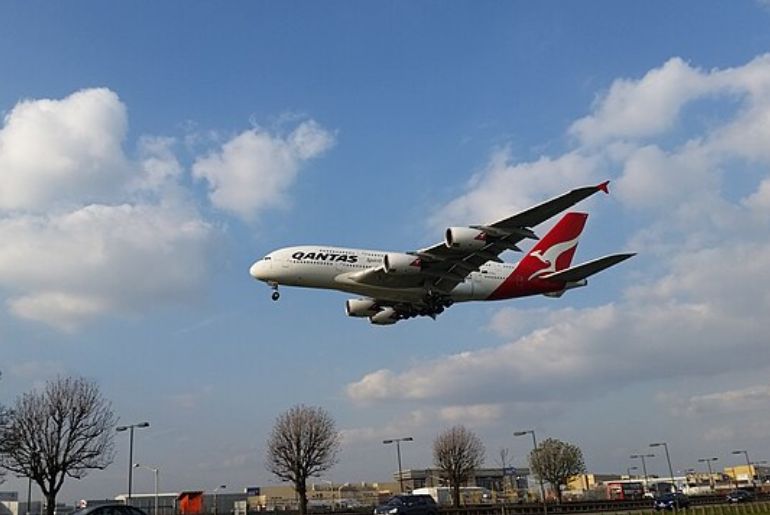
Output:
top-left (433, 425), bottom-right (485, 508)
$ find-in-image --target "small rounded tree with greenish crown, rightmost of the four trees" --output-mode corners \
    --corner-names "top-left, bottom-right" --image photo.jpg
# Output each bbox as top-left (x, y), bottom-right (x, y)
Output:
top-left (529, 438), bottom-right (586, 502)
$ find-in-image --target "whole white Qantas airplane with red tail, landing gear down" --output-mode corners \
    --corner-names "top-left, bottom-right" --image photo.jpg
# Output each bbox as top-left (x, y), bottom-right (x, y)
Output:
top-left (249, 181), bottom-right (634, 325)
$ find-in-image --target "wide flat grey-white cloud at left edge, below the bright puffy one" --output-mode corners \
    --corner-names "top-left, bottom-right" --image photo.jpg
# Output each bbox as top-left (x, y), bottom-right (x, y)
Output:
top-left (0, 204), bottom-right (214, 331)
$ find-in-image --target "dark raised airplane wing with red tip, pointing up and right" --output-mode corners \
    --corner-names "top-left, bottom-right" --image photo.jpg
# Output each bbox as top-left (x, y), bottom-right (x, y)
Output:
top-left (409, 181), bottom-right (609, 293)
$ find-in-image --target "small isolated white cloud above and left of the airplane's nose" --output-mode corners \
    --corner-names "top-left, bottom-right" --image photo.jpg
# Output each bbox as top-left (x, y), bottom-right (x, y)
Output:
top-left (193, 120), bottom-right (334, 220)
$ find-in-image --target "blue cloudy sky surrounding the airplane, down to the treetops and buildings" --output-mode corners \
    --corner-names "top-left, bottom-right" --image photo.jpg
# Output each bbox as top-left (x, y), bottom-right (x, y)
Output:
top-left (0, 0), bottom-right (770, 502)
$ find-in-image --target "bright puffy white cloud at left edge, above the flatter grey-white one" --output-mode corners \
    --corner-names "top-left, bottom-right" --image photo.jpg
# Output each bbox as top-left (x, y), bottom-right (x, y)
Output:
top-left (0, 88), bottom-right (129, 211)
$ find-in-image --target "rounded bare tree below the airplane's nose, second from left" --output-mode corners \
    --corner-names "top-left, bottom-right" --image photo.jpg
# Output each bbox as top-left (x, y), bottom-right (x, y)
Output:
top-left (266, 405), bottom-right (340, 515)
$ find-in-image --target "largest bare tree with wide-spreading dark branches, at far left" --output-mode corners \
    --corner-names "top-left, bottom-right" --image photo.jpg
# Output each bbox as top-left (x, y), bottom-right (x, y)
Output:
top-left (0, 377), bottom-right (115, 515)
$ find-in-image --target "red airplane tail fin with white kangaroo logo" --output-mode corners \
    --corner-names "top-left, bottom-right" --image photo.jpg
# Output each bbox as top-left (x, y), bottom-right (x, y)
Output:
top-left (517, 213), bottom-right (588, 280)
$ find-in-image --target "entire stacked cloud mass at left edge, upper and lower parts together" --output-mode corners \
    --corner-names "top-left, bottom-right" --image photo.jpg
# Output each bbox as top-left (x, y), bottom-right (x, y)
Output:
top-left (0, 89), bottom-right (217, 331)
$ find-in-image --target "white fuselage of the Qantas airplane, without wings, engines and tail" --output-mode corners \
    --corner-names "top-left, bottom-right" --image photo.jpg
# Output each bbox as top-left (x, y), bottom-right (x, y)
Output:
top-left (250, 245), bottom-right (515, 302)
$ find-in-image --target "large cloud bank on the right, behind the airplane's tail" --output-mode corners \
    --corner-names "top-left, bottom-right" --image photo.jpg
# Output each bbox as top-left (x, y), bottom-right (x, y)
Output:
top-left (346, 56), bottom-right (770, 428)
